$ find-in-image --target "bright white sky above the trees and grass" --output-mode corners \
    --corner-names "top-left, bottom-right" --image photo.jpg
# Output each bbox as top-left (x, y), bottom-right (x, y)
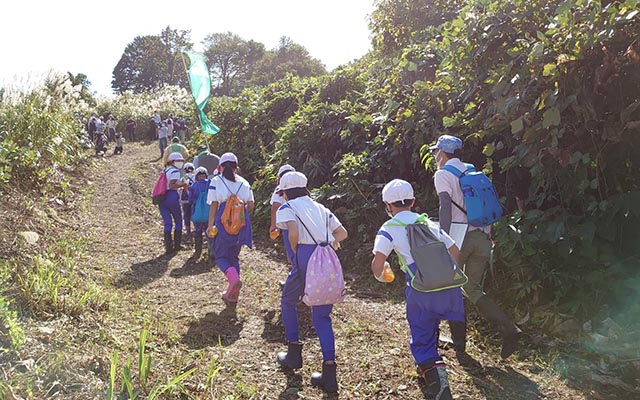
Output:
top-left (0, 0), bottom-right (374, 96)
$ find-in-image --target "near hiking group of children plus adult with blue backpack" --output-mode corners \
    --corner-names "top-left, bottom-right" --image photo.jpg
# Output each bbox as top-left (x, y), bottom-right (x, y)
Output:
top-left (148, 135), bottom-right (520, 400)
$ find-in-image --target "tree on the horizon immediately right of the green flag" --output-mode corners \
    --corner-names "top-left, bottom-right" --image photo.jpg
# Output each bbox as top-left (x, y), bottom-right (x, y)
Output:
top-left (203, 32), bottom-right (265, 95)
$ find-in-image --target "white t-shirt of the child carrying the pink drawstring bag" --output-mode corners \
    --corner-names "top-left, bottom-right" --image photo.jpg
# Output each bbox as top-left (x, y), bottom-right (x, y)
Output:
top-left (276, 196), bottom-right (342, 244)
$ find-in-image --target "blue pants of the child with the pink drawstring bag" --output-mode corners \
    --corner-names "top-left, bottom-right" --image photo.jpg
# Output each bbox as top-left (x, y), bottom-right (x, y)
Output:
top-left (281, 244), bottom-right (336, 361)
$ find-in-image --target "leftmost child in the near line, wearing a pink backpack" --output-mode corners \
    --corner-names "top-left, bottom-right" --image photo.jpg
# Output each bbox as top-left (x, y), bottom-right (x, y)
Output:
top-left (158, 153), bottom-right (186, 254)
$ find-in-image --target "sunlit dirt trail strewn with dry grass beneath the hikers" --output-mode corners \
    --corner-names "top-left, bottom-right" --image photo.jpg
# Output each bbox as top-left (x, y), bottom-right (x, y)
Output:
top-left (85, 143), bottom-right (591, 400)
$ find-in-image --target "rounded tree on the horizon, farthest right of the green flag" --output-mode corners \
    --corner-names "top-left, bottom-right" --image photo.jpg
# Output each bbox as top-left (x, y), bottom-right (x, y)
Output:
top-left (252, 36), bottom-right (327, 85)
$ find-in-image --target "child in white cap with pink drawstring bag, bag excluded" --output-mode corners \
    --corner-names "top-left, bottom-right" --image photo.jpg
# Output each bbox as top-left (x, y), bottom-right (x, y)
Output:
top-left (276, 172), bottom-right (347, 393)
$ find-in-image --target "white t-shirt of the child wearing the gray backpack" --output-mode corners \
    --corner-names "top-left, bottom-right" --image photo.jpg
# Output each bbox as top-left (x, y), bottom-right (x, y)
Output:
top-left (373, 211), bottom-right (455, 265)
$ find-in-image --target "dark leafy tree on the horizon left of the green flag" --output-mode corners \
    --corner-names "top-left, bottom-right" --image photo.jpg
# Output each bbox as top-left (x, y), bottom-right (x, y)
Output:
top-left (111, 27), bottom-right (192, 93)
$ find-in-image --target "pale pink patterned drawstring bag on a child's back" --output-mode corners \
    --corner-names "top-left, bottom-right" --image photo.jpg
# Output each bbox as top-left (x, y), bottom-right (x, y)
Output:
top-left (291, 207), bottom-right (346, 307)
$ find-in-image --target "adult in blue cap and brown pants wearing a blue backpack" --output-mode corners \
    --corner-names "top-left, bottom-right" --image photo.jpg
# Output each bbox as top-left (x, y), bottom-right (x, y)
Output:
top-left (430, 135), bottom-right (520, 358)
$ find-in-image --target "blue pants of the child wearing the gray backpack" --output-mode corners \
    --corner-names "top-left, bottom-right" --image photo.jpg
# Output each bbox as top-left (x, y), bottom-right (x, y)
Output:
top-left (404, 270), bottom-right (464, 365)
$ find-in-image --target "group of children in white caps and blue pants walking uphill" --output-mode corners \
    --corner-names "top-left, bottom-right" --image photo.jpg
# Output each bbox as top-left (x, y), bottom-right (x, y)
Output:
top-left (159, 135), bottom-right (512, 400)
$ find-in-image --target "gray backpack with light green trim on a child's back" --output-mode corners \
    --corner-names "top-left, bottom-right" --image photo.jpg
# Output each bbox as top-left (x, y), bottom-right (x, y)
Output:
top-left (385, 214), bottom-right (469, 292)
